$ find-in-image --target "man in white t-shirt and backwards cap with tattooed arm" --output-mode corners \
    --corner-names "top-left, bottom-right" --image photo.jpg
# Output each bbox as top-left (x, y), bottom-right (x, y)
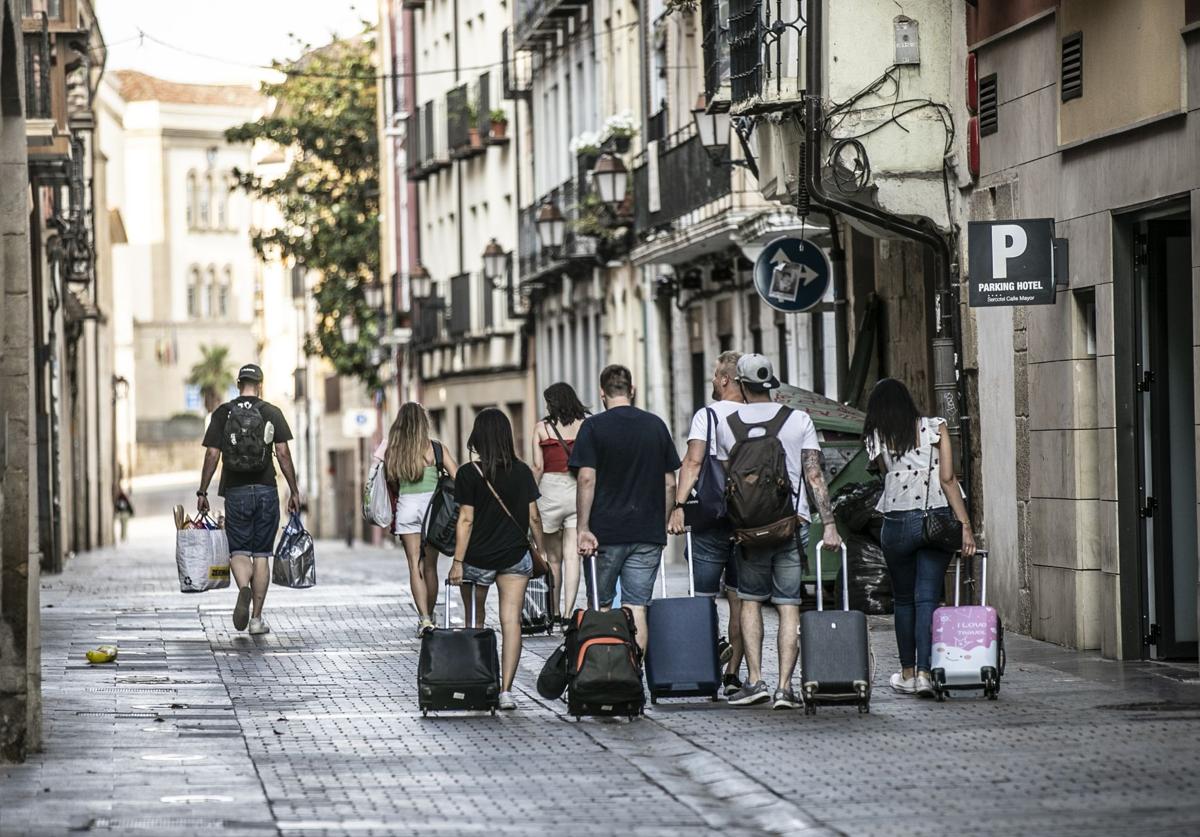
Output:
top-left (716, 355), bottom-right (841, 709)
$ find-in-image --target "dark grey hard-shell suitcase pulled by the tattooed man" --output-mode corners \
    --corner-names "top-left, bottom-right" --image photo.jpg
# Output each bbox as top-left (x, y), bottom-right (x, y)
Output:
top-left (800, 543), bottom-right (872, 715)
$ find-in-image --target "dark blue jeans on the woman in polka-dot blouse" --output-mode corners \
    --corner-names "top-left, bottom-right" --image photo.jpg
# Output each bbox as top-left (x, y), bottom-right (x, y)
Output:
top-left (880, 508), bottom-right (950, 672)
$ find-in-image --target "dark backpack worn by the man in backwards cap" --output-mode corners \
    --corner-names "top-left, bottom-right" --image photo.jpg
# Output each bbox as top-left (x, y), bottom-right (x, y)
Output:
top-left (725, 407), bottom-right (796, 546)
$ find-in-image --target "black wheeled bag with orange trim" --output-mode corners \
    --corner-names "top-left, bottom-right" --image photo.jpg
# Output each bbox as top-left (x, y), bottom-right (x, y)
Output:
top-left (565, 555), bottom-right (646, 721)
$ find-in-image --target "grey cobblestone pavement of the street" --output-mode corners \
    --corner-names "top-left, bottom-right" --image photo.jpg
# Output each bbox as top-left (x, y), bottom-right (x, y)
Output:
top-left (0, 520), bottom-right (1200, 837)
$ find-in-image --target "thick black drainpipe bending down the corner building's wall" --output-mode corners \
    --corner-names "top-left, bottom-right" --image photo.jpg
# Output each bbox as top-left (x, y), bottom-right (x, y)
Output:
top-left (800, 0), bottom-right (972, 508)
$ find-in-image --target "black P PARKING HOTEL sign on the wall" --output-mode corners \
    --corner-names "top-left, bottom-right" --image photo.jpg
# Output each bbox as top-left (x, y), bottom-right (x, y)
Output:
top-left (967, 218), bottom-right (1055, 308)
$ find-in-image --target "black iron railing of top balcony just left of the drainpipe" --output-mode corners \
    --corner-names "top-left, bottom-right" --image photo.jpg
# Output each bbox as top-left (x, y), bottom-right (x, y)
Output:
top-left (730, 0), bottom-right (806, 113)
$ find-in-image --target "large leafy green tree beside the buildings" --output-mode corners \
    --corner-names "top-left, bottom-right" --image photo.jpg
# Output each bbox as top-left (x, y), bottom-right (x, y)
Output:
top-left (226, 31), bottom-right (380, 389)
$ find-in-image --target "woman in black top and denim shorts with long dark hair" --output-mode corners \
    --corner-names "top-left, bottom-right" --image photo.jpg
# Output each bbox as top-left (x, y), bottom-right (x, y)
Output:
top-left (450, 408), bottom-right (546, 709)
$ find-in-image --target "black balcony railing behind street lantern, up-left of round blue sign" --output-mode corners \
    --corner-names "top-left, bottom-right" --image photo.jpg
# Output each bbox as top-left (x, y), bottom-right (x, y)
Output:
top-left (634, 127), bottom-right (731, 235)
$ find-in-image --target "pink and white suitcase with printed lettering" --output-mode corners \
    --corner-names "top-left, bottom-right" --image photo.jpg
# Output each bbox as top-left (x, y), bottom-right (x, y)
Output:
top-left (930, 550), bottom-right (1004, 700)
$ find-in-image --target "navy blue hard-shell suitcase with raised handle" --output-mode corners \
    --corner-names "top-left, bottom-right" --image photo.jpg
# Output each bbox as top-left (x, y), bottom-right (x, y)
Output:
top-left (646, 529), bottom-right (721, 703)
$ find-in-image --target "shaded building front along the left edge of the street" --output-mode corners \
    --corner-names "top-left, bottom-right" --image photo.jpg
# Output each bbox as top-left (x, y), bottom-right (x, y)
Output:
top-left (0, 0), bottom-right (112, 759)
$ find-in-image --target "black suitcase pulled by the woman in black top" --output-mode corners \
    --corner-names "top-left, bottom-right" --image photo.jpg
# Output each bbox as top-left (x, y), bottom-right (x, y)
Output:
top-left (416, 582), bottom-right (500, 715)
